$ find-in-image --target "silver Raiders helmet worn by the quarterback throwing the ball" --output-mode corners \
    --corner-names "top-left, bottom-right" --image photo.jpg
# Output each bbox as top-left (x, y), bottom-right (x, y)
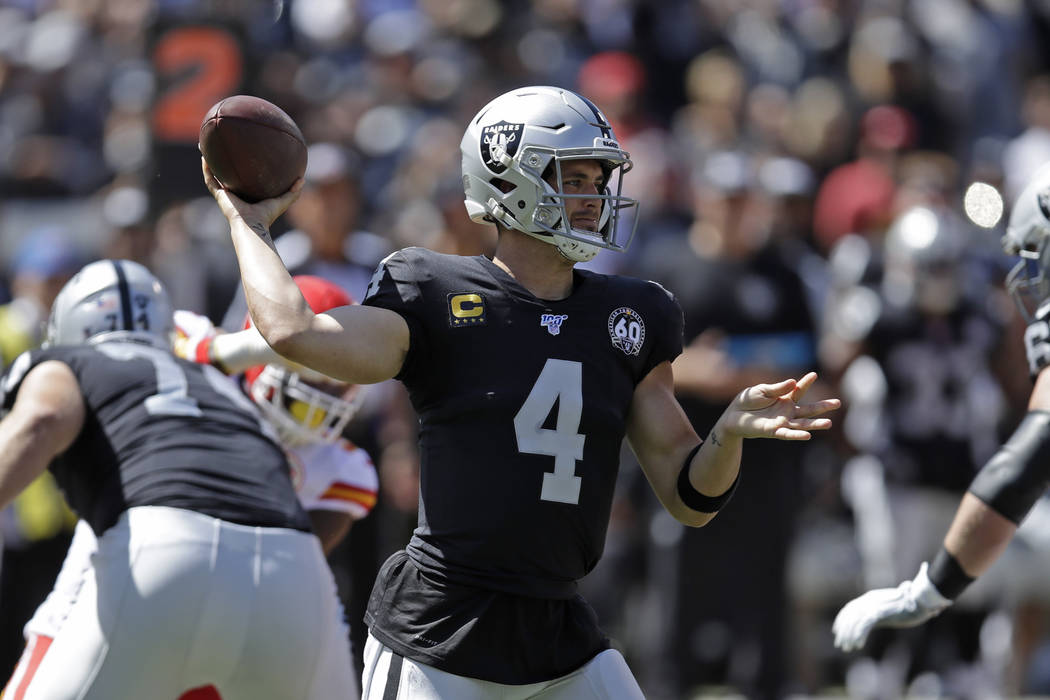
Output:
top-left (460, 86), bottom-right (638, 262)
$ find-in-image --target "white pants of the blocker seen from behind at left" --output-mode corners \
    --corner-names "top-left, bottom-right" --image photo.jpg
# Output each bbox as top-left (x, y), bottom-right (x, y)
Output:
top-left (4, 507), bottom-right (357, 700)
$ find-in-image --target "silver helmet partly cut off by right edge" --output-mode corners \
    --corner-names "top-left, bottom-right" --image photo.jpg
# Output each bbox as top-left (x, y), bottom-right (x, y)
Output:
top-left (1002, 166), bottom-right (1050, 323)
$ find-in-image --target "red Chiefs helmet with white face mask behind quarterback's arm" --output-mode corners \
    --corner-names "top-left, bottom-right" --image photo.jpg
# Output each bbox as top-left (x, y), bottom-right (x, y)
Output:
top-left (245, 275), bottom-right (364, 446)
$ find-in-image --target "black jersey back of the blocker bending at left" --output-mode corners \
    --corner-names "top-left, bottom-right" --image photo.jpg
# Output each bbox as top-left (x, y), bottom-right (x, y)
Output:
top-left (0, 342), bottom-right (310, 535)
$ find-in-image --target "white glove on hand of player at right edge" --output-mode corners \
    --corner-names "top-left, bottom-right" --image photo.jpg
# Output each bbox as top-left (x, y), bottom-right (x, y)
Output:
top-left (832, 561), bottom-right (951, 652)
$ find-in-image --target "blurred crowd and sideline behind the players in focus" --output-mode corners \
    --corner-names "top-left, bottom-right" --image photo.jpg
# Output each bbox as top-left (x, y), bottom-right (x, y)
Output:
top-left (0, 0), bottom-right (1050, 700)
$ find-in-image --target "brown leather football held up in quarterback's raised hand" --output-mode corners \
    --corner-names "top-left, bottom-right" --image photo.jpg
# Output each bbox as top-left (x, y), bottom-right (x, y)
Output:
top-left (200, 94), bottom-right (307, 201)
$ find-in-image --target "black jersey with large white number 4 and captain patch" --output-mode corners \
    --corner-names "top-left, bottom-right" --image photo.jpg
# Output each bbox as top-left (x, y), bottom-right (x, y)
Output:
top-left (363, 248), bottom-right (683, 682)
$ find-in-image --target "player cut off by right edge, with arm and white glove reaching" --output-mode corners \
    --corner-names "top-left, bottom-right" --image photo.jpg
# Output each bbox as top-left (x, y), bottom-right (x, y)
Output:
top-left (833, 168), bottom-right (1050, 651)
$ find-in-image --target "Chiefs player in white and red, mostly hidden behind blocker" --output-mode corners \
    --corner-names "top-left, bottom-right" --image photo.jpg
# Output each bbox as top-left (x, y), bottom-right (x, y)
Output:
top-left (5, 275), bottom-right (379, 700)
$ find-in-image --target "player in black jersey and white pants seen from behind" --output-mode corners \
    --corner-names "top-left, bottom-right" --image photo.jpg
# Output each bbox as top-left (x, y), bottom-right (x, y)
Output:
top-left (0, 260), bottom-right (357, 700)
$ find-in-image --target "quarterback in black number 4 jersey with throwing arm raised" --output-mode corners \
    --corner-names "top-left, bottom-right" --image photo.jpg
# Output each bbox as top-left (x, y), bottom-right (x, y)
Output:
top-left (204, 87), bottom-right (838, 700)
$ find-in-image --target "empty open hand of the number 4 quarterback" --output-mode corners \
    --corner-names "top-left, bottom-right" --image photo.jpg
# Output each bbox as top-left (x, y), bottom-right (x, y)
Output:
top-left (721, 372), bottom-right (841, 440)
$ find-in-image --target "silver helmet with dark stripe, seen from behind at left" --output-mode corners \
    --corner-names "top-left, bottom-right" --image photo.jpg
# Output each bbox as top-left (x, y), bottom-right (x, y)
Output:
top-left (44, 260), bottom-right (175, 349)
